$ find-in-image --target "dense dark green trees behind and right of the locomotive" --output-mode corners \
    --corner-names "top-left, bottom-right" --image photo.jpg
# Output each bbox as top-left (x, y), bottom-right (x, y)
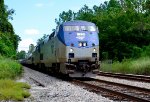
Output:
top-left (55, 0), bottom-right (150, 61)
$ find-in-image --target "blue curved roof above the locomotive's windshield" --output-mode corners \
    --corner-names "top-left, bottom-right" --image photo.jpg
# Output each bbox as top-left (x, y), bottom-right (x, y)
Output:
top-left (63, 20), bottom-right (95, 26)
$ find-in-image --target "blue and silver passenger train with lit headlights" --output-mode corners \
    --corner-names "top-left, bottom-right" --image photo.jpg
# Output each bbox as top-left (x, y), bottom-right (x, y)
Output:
top-left (23, 20), bottom-right (100, 77)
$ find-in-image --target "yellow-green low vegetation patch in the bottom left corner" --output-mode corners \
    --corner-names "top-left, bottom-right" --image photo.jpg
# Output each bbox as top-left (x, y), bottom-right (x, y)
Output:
top-left (0, 80), bottom-right (30, 101)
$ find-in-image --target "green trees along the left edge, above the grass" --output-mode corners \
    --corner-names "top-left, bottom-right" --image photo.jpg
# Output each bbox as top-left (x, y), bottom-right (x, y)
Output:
top-left (0, 0), bottom-right (21, 57)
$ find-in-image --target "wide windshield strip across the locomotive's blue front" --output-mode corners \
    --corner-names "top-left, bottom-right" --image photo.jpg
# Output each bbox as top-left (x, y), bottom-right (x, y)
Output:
top-left (64, 26), bottom-right (96, 31)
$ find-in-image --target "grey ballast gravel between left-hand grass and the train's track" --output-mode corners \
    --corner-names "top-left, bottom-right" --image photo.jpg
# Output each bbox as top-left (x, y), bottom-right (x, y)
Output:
top-left (19, 67), bottom-right (113, 102)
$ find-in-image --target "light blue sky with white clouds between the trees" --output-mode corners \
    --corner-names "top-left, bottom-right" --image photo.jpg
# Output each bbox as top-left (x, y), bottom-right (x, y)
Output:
top-left (5, 0), bottom-right (107, 52)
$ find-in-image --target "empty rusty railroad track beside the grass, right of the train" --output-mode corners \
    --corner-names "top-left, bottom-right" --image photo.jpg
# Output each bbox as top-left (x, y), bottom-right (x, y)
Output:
top-left (98, 72), bottom-right (150, 83)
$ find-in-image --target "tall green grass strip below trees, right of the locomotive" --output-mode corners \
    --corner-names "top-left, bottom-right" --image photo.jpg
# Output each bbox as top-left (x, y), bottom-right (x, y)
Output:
top-left (100, 57), bottom-right (150, 75)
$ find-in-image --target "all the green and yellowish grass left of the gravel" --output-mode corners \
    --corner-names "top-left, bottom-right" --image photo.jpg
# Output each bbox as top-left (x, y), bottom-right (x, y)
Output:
top-left (0, 56), bottom-right (30, 101)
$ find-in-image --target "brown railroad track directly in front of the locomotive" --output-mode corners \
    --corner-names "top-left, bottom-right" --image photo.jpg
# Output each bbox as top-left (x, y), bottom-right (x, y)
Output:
top-left (72, 79), bottom-right (150, 102)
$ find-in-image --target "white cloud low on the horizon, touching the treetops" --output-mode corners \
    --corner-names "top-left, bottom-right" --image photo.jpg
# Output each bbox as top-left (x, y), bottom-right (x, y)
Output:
top-left (18, 38), bottom-right (36, 52)
